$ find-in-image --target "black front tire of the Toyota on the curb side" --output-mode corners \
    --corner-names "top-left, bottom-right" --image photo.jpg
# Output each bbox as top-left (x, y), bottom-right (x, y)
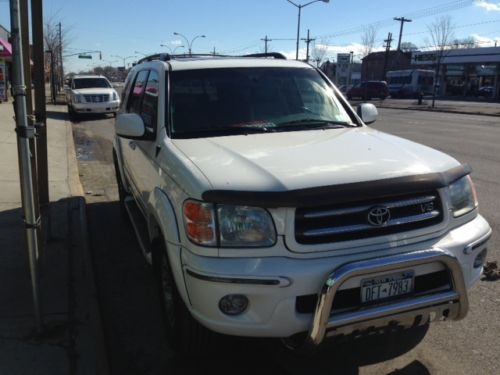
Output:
top-left (153, 238), bottom-right (215, 355)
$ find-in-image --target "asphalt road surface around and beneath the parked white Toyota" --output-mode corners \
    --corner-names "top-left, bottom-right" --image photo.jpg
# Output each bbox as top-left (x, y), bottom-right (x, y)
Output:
top-left (74, 110), bottom-right (500, 375)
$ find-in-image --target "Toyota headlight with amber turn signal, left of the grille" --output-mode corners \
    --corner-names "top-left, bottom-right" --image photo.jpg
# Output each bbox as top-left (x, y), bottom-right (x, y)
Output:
top-left (184, 200), bottom-right (276, 247)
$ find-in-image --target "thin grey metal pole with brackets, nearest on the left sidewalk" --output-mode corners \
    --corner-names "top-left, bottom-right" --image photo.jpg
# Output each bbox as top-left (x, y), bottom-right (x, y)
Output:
top-left (10, 0), bottom-right (43, 331)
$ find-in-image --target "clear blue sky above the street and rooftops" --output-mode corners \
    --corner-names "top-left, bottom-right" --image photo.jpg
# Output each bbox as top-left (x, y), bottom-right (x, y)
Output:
top-left (0, 0), bottom-right (500, 72)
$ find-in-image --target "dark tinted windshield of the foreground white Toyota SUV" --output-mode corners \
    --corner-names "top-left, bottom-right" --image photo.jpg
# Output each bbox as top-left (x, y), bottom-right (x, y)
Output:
top-left (170, 68), bottom-right (355, 138)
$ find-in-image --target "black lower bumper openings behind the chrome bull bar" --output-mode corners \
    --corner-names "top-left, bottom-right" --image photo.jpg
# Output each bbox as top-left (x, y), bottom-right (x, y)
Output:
top-left (295, 270), bottom-right (452, 314)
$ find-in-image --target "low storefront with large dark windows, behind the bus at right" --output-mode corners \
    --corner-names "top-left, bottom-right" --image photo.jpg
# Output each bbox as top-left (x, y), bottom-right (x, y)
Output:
top-left (412, 47), bottom-right (500, 99)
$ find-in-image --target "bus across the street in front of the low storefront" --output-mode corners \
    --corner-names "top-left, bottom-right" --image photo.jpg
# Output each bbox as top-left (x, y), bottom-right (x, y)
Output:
top-left (387, 69), bottom-right (434, 98)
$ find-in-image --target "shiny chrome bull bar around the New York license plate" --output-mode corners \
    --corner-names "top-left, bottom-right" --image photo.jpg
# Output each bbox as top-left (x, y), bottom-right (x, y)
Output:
top-left (306, 249), bottom-right (469, 346)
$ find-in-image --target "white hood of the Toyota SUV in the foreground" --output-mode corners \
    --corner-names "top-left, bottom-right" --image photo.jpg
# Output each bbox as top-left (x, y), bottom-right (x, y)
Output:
top-left (173, 127), bottom-right (459, 191)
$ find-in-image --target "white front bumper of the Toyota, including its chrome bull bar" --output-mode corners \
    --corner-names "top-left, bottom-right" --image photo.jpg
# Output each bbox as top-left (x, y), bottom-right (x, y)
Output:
top-left (182, 215), bottom-right (491, 345)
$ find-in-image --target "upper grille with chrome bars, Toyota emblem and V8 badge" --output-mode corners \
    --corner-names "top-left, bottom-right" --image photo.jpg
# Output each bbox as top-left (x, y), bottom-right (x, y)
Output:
top-left (295, 191), bottom-right (443, 244)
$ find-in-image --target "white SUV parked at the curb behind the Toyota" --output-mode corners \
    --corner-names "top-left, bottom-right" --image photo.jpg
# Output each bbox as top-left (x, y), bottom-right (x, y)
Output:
top-left (66, 75), bottom-right (120, 119)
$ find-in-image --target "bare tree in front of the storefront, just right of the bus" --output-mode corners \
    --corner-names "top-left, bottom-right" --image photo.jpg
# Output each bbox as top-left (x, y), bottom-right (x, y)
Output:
top-left (427, 16), bottom-right (455, 108)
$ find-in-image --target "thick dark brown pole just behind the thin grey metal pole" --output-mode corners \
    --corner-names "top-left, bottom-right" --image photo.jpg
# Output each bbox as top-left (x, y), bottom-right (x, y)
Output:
top-left (31, 0), bottom-right (49, 206)
